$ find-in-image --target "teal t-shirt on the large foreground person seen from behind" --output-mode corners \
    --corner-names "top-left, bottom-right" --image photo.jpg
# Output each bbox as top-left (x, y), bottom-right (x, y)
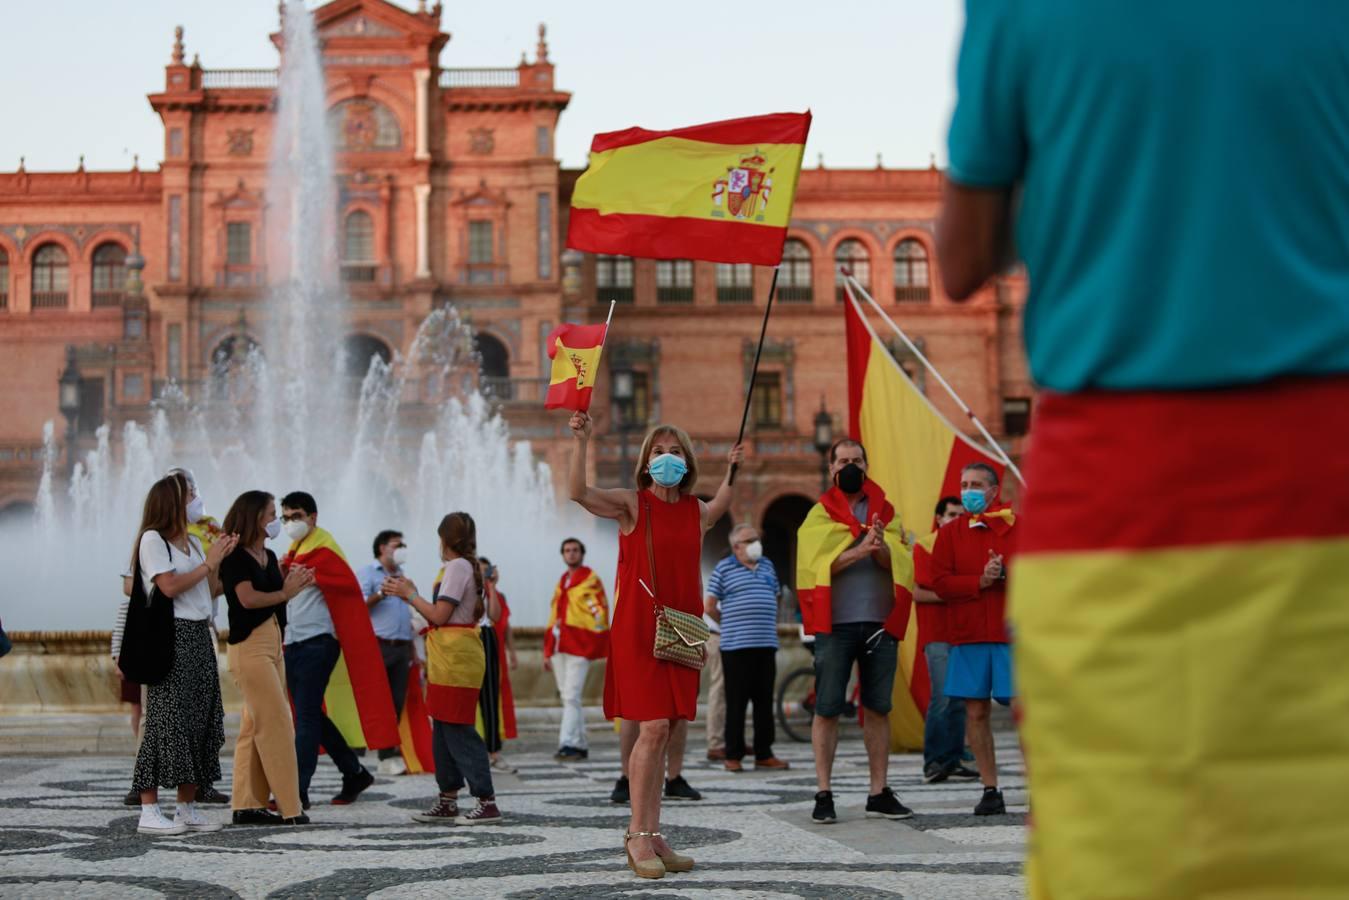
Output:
top-left (950, 0), bottom-right (1349, 391)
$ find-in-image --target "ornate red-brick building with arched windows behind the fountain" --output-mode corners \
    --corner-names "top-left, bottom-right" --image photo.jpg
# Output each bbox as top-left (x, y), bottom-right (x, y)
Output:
top-left (0, 0), bottom-right (1032, 577)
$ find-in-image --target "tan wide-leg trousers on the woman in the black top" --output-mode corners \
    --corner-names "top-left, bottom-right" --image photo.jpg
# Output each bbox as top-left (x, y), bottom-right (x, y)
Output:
top-left (225, 617), bottom-right (302, 819)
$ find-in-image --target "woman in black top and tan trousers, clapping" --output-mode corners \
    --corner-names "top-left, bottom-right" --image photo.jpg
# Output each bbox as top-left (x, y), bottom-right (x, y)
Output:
top-left (220, 491), bottom-right (314, 824)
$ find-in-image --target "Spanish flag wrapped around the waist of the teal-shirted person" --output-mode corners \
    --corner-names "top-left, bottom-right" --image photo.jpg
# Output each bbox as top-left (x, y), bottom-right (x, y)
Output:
top-left (1009, 376), bottom-right (1349, 900)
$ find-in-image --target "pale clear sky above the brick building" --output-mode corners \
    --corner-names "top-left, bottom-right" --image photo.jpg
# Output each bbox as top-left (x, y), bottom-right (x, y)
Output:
top-left (0, 0), bottom-right (963, 171)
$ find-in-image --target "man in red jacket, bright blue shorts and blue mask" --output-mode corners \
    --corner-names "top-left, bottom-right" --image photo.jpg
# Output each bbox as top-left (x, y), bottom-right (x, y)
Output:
top-left (932, 463), bottom-right (1016, 815)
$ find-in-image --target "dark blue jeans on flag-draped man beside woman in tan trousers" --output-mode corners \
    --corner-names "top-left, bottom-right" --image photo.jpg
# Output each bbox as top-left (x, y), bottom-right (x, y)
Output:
top-left (286, 634), bottom-right (362, 797)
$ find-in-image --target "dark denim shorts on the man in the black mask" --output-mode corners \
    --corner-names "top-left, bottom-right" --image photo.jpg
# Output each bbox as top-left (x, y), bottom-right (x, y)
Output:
top-left (815, 622), bottom-right (900, 719)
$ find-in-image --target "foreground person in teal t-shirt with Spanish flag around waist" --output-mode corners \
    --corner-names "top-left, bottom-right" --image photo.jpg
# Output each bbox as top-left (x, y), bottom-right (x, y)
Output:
top-left (938, 0), bottom-right (1349, 900)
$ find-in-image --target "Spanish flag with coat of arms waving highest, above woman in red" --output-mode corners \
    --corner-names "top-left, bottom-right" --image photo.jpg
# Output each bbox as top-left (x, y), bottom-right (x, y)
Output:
top-left (567, 112), bottom-right (811, 266)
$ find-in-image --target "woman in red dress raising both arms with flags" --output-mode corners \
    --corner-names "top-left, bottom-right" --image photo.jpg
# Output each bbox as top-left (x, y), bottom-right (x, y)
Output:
top-left (568, 413), bottom-right (743, 878)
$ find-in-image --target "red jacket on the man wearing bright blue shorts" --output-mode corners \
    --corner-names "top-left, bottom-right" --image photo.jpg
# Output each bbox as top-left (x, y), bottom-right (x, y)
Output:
top-left (932, 506), bottom-right (1017, 644)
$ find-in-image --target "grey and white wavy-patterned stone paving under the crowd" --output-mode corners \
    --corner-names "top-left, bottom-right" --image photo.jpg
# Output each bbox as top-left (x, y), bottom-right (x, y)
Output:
top-left (0, 734), bottom-right (1025, 900)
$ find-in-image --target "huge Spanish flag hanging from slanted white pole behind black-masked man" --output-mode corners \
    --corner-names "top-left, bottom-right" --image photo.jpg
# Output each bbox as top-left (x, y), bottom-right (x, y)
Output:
top-left (843, 283), bottom-right (1004, 749)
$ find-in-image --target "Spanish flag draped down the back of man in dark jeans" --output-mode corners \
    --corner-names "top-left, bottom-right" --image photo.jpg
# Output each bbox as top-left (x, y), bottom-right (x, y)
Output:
top-left (285, 528), bottom-right (398, 750)
